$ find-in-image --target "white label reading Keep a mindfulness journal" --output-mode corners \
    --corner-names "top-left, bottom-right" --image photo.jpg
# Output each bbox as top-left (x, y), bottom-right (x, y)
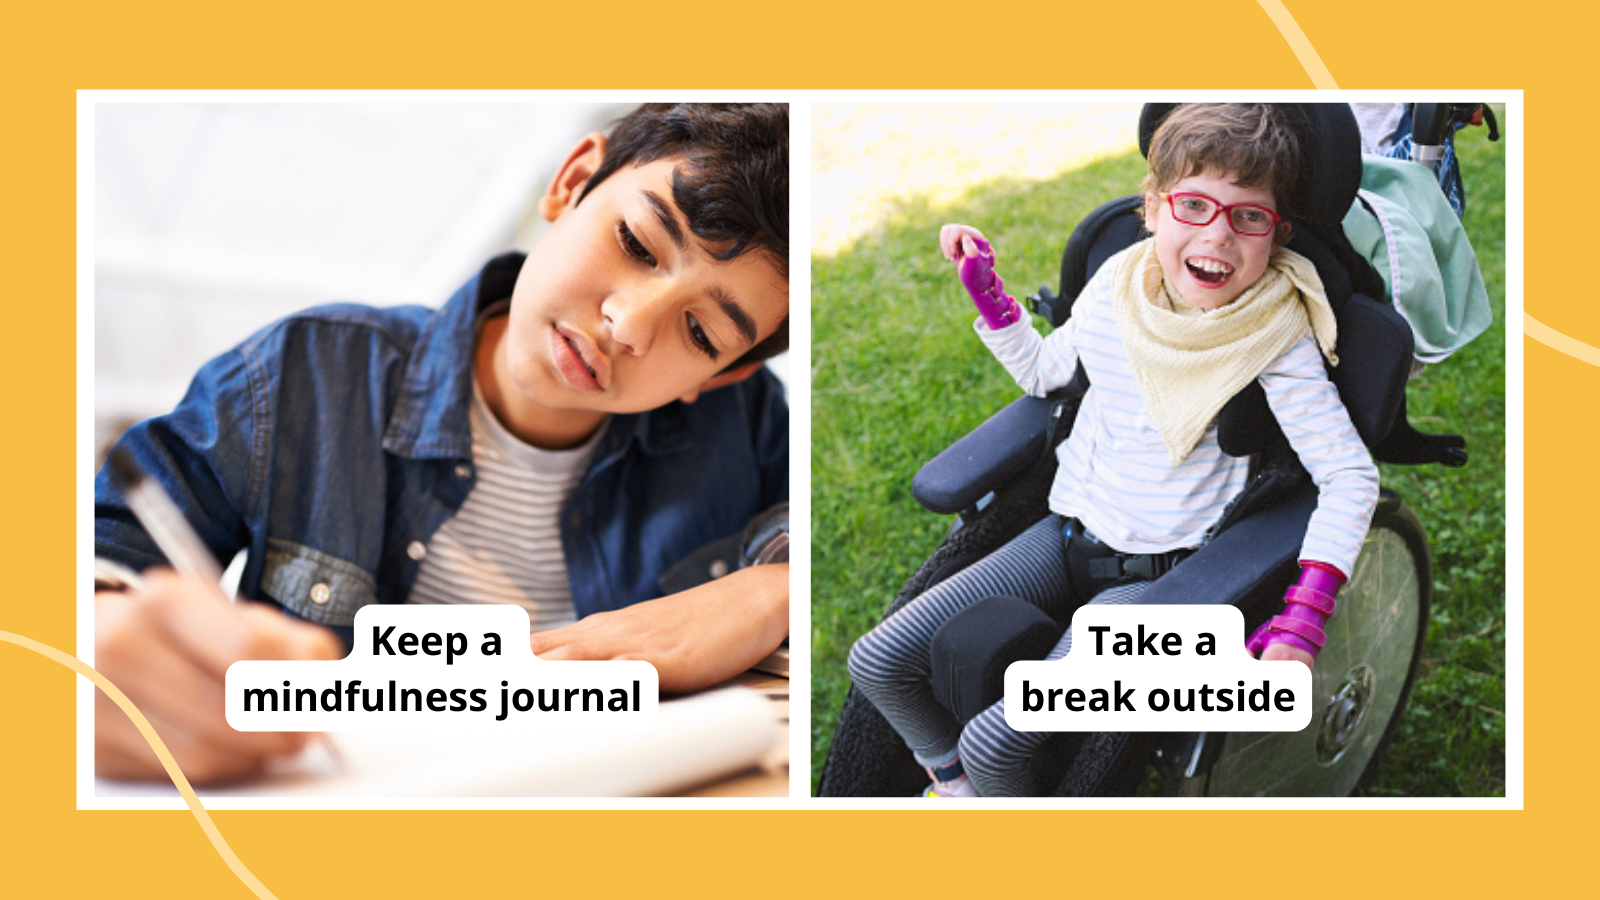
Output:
top-left (226, 604), bottom-right (659, 733)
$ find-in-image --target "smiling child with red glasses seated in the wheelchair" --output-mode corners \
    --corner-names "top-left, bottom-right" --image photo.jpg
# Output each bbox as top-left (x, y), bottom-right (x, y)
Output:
top-left (850, 104), bottom-right (1378, 796)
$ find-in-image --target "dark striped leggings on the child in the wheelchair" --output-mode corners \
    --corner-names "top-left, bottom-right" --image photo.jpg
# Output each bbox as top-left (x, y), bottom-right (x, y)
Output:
top-left (850, 516), bottom-right (1150, 796)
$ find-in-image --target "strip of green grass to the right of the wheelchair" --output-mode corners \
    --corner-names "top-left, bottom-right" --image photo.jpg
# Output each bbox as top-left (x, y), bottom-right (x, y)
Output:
top-left (1370, 122), bottom-right (1506, 796)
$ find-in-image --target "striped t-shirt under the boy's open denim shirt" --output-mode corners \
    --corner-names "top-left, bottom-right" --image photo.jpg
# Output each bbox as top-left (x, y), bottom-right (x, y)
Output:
top-left (410, 376), bottom-right (605, 631)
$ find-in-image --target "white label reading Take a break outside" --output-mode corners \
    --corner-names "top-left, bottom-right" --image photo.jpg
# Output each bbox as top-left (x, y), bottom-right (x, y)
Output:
top-left (1005, 604), bottom-right (1312, 732)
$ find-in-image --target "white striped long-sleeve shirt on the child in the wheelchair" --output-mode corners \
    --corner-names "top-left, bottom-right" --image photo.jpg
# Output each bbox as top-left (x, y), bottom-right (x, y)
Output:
top-left (974, 259), bottom-right (1378, 575)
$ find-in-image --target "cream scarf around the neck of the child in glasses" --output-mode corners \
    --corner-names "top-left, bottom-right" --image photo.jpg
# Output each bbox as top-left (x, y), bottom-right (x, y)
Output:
top-left (1110, 239), bottom-right (1339, 466)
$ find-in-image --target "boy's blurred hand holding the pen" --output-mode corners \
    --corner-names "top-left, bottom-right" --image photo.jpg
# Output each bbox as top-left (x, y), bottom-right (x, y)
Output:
top-left (94, 570), bottom-right (344, 783)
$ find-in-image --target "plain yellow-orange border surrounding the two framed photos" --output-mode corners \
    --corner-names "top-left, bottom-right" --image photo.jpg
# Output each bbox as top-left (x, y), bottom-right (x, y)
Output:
top-left (0, 0), bottom-right (1561, 898)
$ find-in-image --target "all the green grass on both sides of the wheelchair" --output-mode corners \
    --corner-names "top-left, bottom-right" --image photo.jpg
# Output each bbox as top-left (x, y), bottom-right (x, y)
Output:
top-left (811, 117), bottom-right (1506, 796)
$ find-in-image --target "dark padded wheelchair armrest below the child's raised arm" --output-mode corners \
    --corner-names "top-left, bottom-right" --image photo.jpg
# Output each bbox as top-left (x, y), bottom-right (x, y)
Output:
top-left (910, 397), bottom-right (1056, 516)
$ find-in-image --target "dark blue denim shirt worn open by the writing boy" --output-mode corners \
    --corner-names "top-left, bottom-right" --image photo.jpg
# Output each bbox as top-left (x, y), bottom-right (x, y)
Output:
top-left (94, 255), bottom-right (789, 644)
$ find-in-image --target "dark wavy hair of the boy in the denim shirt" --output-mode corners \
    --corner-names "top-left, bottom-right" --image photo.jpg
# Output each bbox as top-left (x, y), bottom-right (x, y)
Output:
top-left (578, 102), bottom-right (789, 368)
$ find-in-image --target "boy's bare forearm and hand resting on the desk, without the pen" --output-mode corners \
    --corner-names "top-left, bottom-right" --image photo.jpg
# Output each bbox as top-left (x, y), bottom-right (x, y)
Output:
top-left (531, 562), bottom-right (789, 693)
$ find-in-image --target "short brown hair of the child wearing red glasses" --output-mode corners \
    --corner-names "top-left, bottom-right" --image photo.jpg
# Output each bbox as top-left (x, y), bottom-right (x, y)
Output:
top-left (1144, 102), bottom-right (1302, 219)
